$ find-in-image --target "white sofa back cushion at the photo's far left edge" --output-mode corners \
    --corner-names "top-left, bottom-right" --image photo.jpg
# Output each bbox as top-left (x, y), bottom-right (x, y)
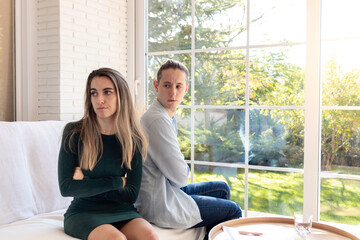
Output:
top-left (0, 122), bottom-right (36, 224)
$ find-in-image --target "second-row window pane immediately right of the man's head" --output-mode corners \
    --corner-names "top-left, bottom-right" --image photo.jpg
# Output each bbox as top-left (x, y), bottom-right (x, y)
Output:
top-left (195, 50), bottom-right (246, 106)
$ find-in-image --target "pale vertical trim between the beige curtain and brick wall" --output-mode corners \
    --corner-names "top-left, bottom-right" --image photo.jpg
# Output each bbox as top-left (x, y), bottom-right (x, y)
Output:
top-left (14, 0), bottom-right (38, 121)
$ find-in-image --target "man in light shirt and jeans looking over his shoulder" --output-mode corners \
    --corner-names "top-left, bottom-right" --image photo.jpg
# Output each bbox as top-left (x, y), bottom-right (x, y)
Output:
top-left (136, 60), bottom-right (241, 237)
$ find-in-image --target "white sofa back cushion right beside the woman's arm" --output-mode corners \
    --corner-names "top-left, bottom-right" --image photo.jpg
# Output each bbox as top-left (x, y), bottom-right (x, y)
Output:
top-left (20, 121), bottom-right (72, 214)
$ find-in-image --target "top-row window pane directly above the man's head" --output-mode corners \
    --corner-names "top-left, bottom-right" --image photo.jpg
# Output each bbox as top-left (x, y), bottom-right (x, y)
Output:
top-left (147, 0), bottom-right (191, 52)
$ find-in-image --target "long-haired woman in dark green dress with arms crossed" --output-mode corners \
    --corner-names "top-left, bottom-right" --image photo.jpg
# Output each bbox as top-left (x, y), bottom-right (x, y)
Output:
top-left (58, 68), bottom-right (158, 240)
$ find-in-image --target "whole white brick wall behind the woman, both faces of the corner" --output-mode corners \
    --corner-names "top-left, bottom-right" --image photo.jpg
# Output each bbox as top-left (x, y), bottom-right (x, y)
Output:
top-left (37, 0), bottom-right (128, 120)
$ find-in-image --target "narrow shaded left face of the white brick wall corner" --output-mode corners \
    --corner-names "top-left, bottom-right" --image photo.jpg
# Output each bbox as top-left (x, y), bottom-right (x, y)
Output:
top-left (37, 0), bottom-right (60, 120)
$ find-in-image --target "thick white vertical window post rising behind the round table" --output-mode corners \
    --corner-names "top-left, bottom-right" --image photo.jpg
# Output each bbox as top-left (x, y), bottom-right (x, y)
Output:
top-left (303, 0), bottom-right (321, 221)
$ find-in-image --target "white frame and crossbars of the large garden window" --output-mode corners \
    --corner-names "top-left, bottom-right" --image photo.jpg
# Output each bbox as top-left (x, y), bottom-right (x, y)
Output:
top-left (135, 0), bottom-right (360, 221)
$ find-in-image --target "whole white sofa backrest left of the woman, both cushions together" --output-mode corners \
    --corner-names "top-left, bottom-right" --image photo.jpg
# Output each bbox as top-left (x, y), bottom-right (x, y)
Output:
top-left (0, 121), bottom-right (71, 224)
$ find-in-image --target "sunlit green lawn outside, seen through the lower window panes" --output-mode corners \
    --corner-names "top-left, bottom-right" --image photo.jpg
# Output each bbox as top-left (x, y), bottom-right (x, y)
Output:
top-left (194, 169), bottom-right (360, 224)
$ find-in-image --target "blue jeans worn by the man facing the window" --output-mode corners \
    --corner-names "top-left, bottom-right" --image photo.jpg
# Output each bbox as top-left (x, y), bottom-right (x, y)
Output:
top-left (181, 181), bottom-right (242, 239)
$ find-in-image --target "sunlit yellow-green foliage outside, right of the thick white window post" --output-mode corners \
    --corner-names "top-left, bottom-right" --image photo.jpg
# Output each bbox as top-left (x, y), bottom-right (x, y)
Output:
top-left (321, 58), bottom-right (360, 171)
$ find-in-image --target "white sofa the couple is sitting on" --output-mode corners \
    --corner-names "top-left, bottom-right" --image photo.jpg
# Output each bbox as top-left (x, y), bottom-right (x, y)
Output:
top-left (0, 121), bottom-right (205, 240)
